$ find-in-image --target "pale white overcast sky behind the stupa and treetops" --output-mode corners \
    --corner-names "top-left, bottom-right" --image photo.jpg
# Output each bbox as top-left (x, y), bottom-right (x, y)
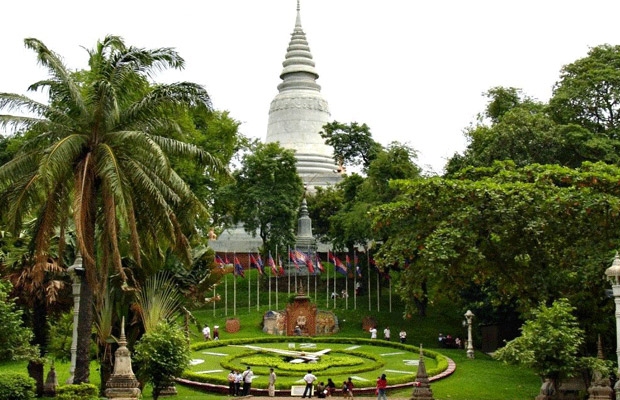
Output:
top-left (0, 0), bottom-right (620, 172)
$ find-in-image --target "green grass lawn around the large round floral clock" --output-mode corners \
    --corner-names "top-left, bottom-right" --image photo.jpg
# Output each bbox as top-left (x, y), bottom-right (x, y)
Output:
top-left (0, 271), bottom-right (540, 400)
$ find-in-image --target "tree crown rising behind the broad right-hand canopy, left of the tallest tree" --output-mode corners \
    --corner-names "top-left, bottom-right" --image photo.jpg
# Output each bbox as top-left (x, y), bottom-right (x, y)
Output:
top-left (445, 87), bottom-right (620, 175)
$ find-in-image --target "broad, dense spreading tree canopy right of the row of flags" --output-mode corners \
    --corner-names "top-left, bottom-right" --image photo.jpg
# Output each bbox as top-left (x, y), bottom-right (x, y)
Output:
top-left (371, 162), bottom-right (620, 326)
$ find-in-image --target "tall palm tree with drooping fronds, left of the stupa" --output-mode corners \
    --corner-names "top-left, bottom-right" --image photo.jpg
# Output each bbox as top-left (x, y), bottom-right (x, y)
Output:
top-left (0, 36), bottom-right (222, 383)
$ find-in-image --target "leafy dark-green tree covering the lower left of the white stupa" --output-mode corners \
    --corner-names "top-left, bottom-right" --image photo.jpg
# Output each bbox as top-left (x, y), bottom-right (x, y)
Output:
top-left (220, 143), bottom-right (304, 251)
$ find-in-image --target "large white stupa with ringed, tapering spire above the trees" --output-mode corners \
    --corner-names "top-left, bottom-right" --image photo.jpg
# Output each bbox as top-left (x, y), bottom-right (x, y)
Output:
top-left (266, 0), bottom-right (342, 191)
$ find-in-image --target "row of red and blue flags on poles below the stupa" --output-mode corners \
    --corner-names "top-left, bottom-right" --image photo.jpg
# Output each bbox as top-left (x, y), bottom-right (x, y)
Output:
top-left (215, 250), bottom-right (392, 280)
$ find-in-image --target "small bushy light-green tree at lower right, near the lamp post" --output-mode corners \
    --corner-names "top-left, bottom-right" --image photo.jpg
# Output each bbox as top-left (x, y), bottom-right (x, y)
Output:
top-left (494, 299), bottom-right (584, 388)
